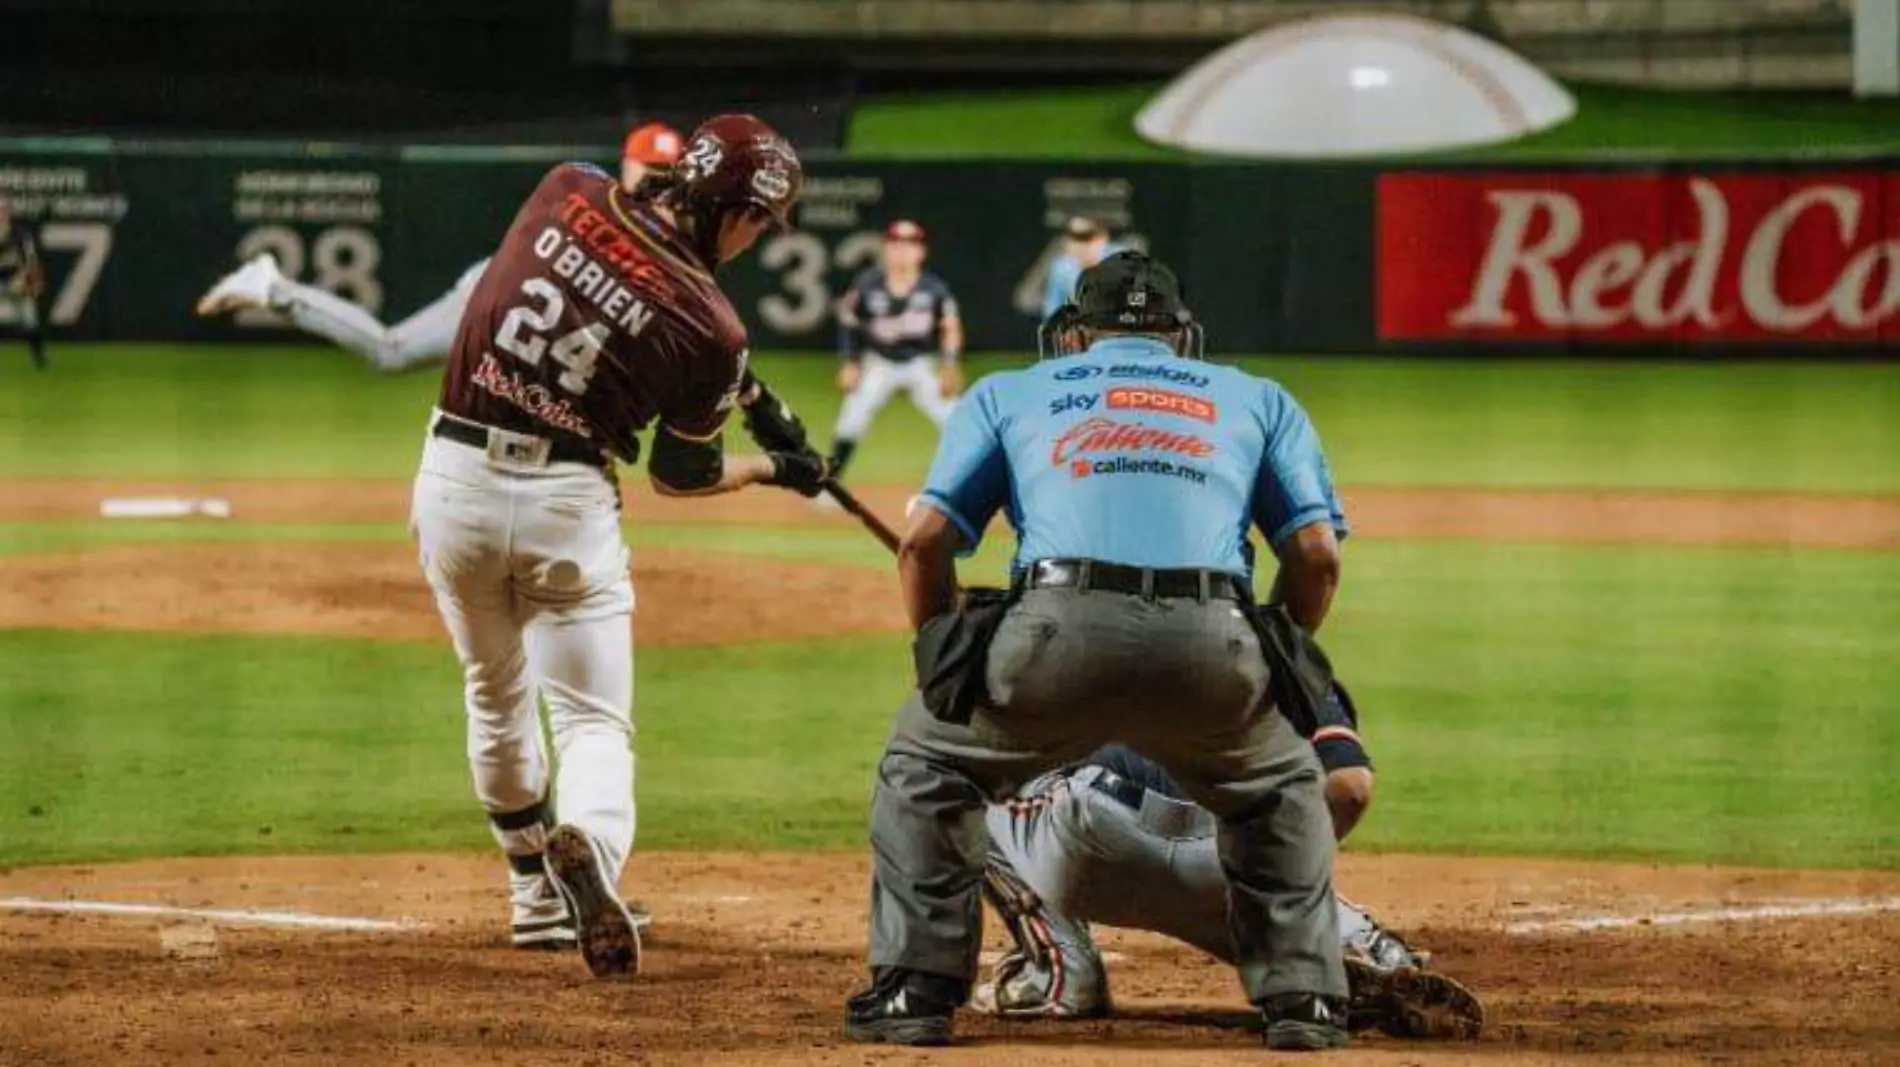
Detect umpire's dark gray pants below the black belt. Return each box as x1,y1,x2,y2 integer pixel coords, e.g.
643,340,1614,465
870,589,1347,1002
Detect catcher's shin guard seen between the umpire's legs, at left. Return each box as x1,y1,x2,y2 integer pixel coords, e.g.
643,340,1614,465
969,858,1110,1020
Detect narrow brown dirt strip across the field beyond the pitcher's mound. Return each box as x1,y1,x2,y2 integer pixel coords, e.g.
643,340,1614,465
0,478,1900,549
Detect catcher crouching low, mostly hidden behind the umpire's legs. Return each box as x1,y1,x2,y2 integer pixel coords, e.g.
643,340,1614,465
971,702,1484,1037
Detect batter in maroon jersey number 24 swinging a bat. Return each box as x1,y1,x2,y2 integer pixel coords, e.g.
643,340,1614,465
412,116,827,976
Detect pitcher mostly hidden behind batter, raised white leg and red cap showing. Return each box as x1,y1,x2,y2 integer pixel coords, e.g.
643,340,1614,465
198,122,682,370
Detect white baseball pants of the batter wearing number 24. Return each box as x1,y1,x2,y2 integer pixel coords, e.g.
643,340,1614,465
412,411,635,879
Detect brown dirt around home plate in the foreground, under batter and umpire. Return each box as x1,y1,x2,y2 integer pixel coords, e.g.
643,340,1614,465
0,854,1900,1067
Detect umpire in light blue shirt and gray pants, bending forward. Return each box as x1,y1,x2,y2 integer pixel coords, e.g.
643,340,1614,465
846,253,1347,1050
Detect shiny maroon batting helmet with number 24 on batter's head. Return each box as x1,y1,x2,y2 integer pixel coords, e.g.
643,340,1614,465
673,114,806,230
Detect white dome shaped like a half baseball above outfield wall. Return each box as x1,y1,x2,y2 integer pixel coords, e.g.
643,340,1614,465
1134,15,1577,158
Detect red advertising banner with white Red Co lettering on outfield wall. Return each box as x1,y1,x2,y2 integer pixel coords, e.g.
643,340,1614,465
1378,171,1900,344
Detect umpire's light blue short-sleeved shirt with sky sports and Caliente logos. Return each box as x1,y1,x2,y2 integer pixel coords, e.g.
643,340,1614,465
922,336,1347,579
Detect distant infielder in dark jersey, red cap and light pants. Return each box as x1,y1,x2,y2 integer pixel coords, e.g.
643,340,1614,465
830,220,963,473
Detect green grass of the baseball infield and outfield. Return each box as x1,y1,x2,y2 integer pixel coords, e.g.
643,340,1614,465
0,346,1900,868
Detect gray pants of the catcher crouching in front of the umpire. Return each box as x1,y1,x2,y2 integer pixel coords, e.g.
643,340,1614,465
986,767,1374,1014
